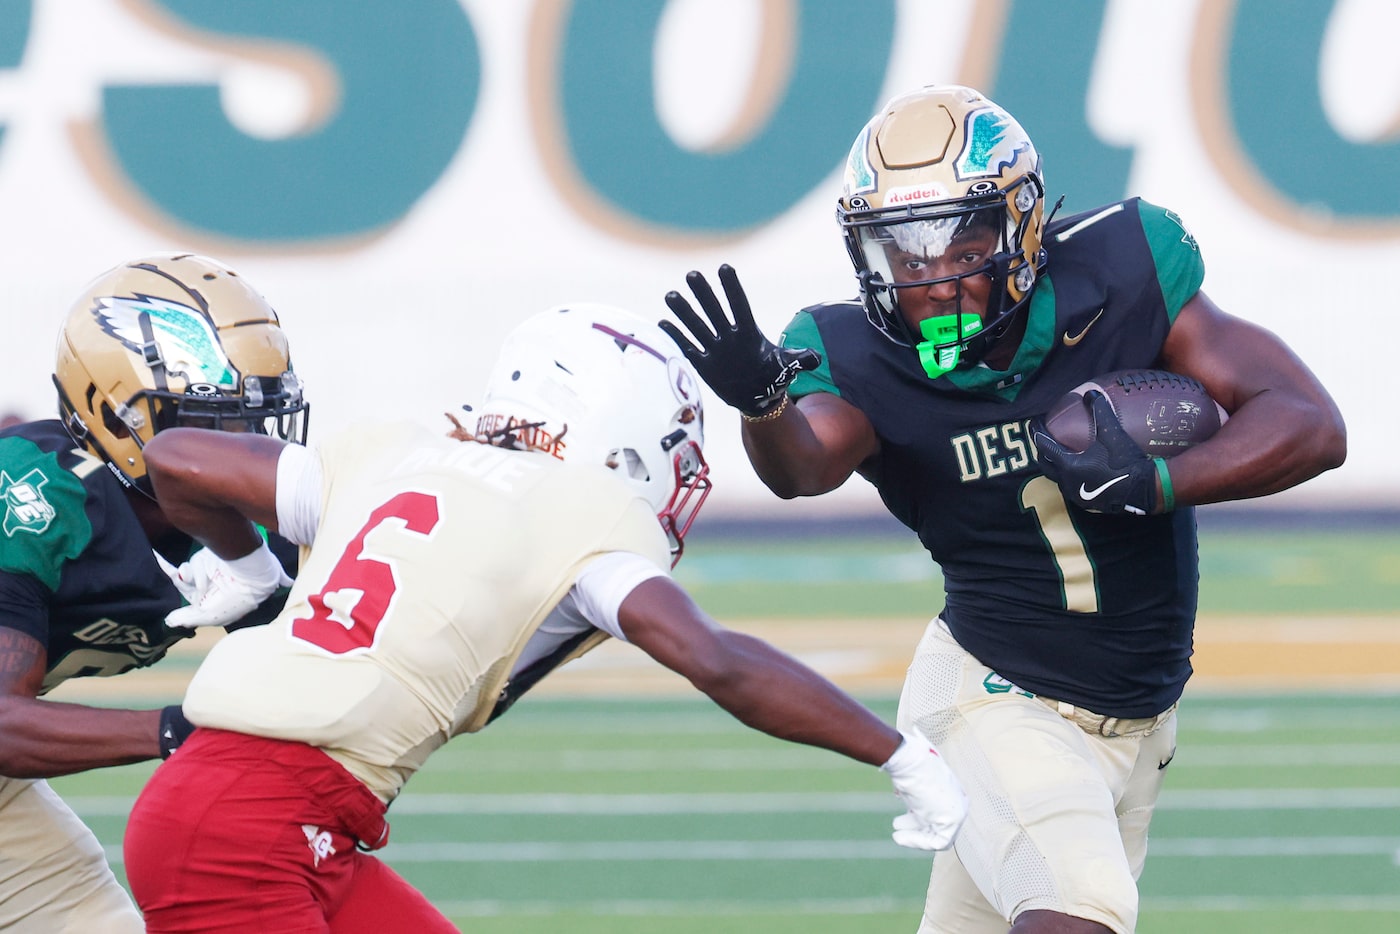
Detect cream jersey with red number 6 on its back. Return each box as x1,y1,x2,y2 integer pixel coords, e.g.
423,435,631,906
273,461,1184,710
183,424,671,801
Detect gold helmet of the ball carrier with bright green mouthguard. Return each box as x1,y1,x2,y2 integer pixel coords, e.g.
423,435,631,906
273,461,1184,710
836,85,1044,378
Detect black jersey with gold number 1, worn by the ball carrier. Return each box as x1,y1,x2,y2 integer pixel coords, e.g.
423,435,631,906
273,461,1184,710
783,199,1204,717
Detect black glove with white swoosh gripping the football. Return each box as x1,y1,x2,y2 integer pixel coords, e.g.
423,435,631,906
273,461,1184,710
1030,389,1161,515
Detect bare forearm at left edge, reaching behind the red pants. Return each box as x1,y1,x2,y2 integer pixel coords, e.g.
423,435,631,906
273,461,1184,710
0,697,161,779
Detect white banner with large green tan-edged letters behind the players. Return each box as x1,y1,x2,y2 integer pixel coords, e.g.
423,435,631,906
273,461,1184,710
0,0,1400,517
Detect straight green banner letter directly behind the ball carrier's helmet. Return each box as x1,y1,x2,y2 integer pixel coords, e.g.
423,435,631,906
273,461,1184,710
979,0,1133,213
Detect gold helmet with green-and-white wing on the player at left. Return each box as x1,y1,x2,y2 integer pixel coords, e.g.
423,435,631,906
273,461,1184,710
53,253,308,496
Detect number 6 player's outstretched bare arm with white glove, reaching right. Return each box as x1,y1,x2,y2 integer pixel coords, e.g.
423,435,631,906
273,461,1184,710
617,577,967,850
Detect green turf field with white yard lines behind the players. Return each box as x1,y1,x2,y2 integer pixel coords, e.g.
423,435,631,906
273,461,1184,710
43,531,1400,934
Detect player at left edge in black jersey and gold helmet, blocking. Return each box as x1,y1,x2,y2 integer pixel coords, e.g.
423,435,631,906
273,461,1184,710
0,253,307,934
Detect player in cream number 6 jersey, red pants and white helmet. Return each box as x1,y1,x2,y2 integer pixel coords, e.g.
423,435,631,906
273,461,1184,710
125,305,966,934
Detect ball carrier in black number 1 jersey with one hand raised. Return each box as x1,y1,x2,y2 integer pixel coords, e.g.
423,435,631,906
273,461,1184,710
662,85,1345,934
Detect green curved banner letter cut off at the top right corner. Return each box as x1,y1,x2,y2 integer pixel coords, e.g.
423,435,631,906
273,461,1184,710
1219,0,1400,221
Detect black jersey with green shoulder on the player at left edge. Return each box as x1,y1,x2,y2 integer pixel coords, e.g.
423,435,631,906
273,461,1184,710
0,420,295,693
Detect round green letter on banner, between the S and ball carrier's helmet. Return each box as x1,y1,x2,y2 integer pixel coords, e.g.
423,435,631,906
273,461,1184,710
547,0,895,234
